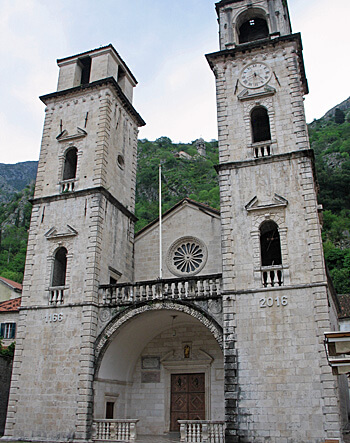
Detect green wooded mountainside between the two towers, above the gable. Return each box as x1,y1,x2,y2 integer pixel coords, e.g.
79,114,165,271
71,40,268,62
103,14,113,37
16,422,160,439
135,137,220,231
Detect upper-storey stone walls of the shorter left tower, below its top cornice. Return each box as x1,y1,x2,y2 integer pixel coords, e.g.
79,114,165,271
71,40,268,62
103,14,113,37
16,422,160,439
35,86,138,211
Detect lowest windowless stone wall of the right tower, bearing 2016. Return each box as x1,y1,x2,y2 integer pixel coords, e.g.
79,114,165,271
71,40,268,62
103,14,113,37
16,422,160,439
230,288,340,443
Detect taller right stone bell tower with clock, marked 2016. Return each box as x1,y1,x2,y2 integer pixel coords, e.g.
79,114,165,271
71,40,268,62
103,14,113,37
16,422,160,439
207,0,342,443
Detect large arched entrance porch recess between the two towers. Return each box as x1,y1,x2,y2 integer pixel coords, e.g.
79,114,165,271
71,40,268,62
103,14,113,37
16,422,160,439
94,302,224,435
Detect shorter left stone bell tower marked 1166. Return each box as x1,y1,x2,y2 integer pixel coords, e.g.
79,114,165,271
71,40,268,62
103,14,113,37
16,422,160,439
5,45,144,441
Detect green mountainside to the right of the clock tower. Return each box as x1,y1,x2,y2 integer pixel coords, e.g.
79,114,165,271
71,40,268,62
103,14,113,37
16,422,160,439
309,98,350,294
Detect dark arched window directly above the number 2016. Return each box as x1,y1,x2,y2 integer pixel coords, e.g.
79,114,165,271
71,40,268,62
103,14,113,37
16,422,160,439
260,220,282,266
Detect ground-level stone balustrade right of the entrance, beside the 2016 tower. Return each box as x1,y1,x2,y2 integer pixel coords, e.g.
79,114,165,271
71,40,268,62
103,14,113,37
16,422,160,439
178,420,225,443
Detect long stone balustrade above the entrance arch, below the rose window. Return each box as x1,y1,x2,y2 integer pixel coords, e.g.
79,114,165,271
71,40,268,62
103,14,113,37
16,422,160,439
99,274,221,305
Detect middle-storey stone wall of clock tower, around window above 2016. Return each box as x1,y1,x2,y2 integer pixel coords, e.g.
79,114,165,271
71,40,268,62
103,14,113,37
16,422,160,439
220,151,326,290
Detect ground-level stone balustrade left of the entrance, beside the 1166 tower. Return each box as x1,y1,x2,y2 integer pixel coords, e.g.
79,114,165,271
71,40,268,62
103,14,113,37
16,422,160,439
92,419,138,442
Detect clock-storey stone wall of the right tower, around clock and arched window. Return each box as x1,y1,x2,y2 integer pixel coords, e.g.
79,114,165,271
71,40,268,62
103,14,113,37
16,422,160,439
212,37,309,163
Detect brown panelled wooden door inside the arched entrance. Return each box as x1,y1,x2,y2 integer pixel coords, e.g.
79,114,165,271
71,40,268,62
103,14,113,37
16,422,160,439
170,374,205,431
